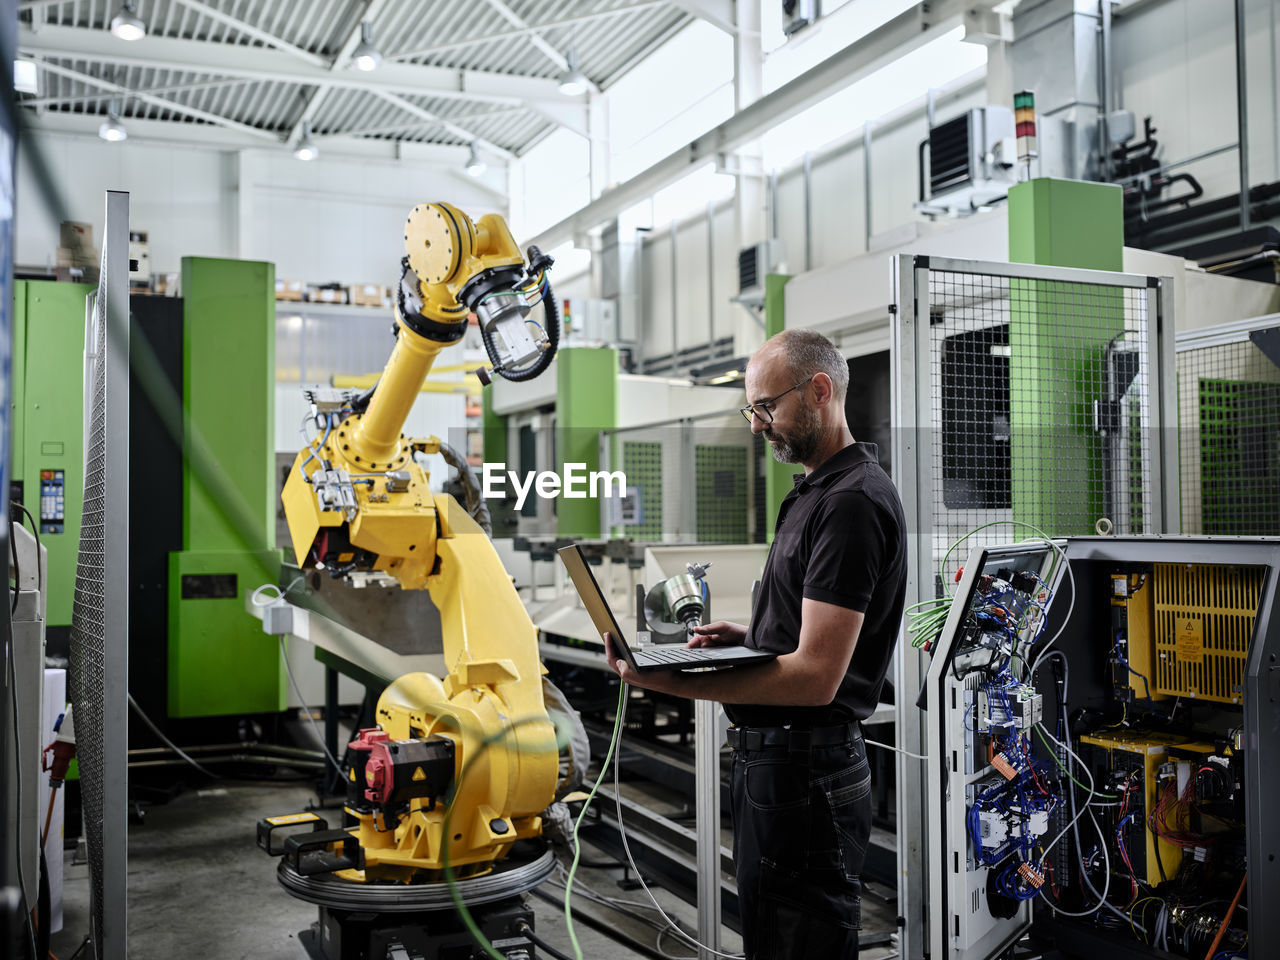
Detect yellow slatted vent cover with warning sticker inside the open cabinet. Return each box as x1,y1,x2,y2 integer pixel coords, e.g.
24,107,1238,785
1152,563,1266,704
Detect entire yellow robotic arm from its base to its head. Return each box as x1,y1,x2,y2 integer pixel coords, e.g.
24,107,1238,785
283,204,558,882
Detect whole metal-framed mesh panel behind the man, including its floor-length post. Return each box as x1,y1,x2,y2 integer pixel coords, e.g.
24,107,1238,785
891,256,1178,956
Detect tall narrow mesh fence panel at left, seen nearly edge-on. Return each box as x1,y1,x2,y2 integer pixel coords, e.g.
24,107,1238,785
70,277,111,956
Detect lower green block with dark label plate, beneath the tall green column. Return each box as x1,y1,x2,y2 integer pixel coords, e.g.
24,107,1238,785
169,550,287,717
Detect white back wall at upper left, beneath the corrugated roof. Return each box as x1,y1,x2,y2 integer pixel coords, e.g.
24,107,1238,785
15,133,506,284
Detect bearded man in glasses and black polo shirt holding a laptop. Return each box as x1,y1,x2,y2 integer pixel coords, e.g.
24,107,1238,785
605,330,906,960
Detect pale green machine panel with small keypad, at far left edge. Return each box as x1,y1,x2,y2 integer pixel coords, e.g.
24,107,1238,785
13,280,95,627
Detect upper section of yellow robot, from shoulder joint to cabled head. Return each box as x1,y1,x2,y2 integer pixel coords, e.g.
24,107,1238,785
284,204,559,590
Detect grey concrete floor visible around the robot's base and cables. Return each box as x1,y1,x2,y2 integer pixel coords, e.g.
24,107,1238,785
51,781,895,960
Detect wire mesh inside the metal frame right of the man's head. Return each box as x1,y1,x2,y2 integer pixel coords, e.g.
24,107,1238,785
902,263,1153,593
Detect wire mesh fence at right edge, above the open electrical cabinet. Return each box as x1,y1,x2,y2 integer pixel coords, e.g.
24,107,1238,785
1178,330,1280,536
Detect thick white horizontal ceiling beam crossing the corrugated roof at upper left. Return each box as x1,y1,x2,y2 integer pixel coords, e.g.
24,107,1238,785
18,23,563,106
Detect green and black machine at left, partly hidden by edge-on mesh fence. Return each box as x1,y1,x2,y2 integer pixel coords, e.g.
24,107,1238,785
12,259,287,721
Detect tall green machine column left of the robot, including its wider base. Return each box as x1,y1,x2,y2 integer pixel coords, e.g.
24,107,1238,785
167,257,287,717
